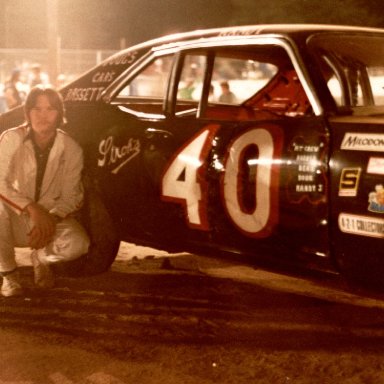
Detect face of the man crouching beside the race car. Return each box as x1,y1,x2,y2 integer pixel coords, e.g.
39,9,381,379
29,95,59,135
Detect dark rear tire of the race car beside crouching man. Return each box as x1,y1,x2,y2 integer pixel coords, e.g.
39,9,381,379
54,178,120,277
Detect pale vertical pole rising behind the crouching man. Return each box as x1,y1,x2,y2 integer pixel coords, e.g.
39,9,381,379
45,0,60,86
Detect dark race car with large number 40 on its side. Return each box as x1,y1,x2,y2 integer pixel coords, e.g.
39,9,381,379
0,25,384,286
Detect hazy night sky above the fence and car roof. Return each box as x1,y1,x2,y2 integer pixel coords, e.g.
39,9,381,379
0,0,384,49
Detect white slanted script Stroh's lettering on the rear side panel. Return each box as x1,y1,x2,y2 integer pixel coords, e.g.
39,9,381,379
97,136,140,174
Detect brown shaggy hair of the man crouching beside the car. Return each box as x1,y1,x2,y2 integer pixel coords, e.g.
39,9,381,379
24,86,64,128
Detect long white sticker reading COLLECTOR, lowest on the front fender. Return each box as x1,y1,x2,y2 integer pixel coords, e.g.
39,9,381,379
339,213,384,239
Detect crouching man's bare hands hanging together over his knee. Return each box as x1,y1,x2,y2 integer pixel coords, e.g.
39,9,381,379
25,203,56,249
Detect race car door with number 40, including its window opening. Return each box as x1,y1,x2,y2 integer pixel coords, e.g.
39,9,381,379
136,44,329,263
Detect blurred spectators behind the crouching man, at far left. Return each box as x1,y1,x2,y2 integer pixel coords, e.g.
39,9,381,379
0,63,50,113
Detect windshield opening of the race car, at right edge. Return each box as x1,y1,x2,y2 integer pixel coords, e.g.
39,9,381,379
308,33,384,113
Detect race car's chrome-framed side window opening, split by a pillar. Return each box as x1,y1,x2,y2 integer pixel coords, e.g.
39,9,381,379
112,45,312,120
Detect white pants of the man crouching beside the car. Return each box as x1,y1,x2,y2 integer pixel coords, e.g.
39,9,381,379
0,201,89,273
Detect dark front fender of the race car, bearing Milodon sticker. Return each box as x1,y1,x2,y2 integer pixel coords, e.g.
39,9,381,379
330,116,384,282
